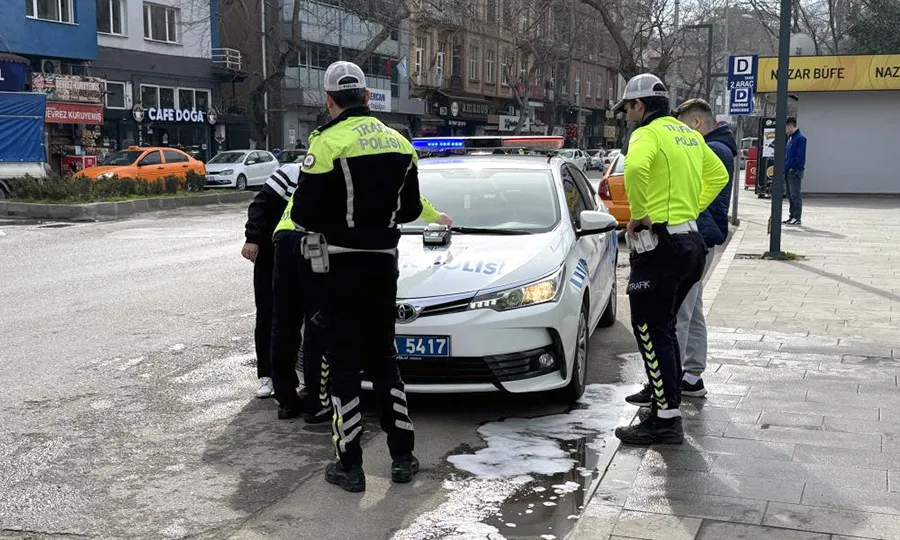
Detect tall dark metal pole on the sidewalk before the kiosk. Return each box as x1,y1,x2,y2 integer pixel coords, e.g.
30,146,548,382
768,0,792,257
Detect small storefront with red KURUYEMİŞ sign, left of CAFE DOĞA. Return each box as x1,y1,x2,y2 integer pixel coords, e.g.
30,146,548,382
31,73,104,174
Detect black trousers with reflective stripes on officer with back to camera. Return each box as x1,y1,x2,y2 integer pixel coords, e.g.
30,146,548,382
321,253,414,467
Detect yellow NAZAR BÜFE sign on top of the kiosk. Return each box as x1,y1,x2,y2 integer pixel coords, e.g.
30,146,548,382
757,54,900,92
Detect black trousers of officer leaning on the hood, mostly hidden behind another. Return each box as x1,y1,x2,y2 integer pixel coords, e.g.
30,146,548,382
271,231,331,414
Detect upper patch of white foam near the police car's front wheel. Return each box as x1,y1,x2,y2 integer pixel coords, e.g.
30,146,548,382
447,384,634,479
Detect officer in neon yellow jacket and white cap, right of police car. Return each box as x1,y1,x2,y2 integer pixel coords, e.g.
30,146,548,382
616,74,728,445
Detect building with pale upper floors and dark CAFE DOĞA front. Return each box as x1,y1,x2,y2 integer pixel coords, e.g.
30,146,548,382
90,0,249,160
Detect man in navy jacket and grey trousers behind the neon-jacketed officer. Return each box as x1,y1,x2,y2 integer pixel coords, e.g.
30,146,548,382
675,99,737,397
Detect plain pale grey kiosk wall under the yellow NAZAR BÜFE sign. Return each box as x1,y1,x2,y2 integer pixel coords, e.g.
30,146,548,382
797,91,900,194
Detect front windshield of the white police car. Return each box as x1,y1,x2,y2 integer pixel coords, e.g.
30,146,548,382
403,168,559,234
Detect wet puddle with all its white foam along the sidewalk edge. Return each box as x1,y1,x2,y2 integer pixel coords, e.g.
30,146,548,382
393,384,635,540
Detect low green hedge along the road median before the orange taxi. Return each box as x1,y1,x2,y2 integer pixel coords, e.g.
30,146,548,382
7,171,206,202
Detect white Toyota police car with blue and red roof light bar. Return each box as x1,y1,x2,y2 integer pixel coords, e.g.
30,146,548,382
380,137,618,400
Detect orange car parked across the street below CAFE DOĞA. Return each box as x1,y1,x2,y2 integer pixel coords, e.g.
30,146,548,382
76,146,206,184
